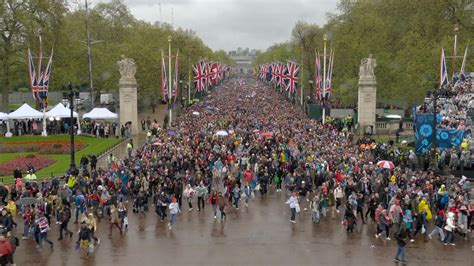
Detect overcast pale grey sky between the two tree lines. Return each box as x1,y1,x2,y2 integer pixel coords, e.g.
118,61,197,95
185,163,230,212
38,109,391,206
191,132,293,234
91,0,339,51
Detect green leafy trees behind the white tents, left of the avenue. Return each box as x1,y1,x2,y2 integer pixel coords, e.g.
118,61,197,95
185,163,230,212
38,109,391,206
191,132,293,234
0,0,232,111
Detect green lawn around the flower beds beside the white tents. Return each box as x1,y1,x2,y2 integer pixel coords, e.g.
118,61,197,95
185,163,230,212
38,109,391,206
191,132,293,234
0,135,120,183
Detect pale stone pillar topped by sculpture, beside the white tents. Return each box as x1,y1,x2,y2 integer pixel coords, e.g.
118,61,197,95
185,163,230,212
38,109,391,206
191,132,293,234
117,56,139,135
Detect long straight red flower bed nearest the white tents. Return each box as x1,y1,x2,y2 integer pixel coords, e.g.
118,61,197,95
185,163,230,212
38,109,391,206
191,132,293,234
0,140,87,154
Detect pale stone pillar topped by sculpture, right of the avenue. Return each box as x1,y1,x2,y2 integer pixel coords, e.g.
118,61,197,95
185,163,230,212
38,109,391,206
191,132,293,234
357,55,377,134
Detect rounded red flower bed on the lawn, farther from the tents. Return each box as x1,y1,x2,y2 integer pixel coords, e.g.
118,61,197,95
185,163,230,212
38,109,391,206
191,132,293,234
0,154,56,176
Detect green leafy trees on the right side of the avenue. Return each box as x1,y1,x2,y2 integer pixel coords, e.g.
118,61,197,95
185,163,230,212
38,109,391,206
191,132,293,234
253,0,474,107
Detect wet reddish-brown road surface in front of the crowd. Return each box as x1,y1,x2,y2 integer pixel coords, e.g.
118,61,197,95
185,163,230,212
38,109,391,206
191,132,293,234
15,190,474,266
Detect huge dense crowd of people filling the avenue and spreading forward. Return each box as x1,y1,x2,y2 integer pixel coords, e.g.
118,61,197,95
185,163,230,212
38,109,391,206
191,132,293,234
0,78,474,262
